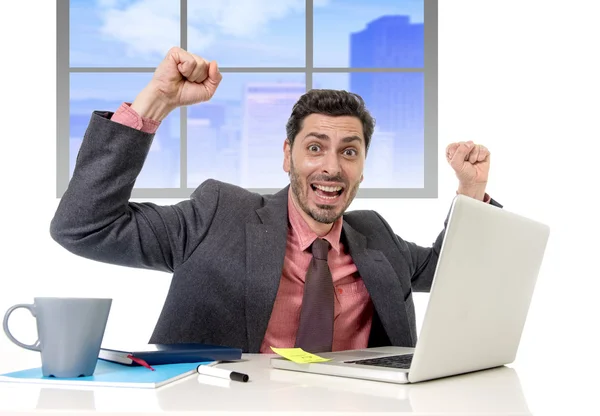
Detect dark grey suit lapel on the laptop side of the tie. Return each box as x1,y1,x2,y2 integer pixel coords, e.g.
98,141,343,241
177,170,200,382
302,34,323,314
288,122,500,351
343,221,414,346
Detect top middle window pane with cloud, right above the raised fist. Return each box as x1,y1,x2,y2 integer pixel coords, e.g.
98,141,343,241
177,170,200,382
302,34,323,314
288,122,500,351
188,0,306,67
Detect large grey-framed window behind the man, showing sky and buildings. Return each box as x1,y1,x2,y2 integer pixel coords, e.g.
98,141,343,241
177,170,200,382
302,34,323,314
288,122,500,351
57,0,437,198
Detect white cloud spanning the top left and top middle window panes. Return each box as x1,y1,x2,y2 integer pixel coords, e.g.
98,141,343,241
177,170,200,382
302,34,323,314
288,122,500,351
97,0,329,58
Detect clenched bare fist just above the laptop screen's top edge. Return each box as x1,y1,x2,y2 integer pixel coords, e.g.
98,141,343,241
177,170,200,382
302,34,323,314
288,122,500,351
446,141,490,200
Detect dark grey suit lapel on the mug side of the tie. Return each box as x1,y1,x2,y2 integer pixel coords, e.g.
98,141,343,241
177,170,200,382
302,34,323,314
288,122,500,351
246,186,289,352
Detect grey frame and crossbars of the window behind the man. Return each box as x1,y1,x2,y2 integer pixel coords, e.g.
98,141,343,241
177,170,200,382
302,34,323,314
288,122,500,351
56,0,438,199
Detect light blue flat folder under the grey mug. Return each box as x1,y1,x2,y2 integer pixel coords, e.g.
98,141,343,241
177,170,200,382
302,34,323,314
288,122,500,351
0,360,211,388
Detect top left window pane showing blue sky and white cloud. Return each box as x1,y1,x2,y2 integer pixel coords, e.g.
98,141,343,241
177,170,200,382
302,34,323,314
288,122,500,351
69,0,180,67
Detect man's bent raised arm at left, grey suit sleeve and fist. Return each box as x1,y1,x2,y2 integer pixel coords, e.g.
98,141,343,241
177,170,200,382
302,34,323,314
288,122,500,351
50,48,222,271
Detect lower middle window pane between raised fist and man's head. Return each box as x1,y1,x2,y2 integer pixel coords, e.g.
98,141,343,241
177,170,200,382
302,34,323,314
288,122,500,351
187,73,306,189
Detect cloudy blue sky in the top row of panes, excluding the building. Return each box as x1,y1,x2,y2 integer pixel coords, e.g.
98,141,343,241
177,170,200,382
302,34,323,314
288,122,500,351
70,0,423,67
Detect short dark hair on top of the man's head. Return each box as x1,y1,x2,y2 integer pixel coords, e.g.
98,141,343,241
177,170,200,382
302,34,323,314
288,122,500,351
285,89,375,150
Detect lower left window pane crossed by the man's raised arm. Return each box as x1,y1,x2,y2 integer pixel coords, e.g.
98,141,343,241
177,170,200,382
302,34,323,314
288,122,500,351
69,73,180,188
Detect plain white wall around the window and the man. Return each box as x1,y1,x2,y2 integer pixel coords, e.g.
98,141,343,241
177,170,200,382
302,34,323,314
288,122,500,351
0,0,600,414
